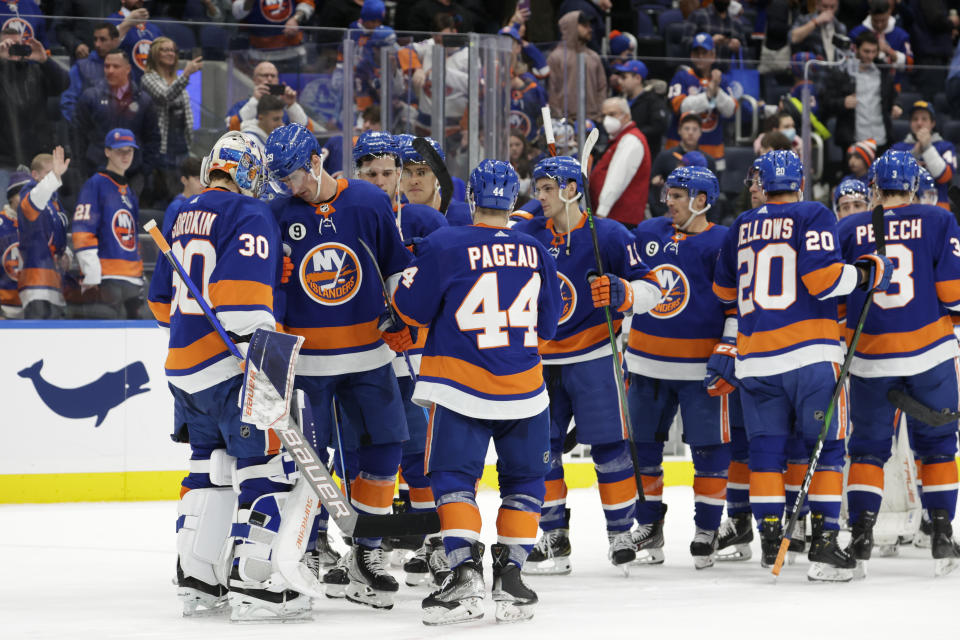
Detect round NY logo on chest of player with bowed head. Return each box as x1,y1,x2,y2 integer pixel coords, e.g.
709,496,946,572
300,242,363,307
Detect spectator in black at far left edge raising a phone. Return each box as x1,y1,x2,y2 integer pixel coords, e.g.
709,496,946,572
0,26,69,184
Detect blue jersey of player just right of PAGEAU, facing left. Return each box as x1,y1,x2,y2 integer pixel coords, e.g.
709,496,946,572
513,214,649,364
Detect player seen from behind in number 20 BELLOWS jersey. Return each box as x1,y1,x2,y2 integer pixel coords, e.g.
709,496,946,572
706,151,892,581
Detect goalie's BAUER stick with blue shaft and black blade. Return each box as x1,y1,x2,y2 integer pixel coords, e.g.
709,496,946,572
143,220,440,538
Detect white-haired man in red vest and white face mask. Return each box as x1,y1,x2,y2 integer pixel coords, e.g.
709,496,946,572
590,98,652,225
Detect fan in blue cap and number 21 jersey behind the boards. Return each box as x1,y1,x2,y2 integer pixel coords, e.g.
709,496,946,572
73,129,144,319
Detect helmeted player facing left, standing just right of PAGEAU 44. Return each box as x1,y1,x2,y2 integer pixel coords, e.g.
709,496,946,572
513,156,660,574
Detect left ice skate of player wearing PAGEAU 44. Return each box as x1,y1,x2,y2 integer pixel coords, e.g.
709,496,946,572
420,543,486,626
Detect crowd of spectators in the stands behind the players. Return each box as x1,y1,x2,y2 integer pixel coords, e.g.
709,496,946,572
0,0,960,318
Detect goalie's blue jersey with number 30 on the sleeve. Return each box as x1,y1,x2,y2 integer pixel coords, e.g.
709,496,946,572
148,189,283,393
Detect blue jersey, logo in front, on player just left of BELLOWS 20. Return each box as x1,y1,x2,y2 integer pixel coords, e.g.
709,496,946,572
627,218,736,380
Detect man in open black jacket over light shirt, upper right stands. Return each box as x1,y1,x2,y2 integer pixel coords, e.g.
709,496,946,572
821,31,902,150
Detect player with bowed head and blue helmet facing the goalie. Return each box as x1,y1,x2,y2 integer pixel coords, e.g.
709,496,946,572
266,124,413,609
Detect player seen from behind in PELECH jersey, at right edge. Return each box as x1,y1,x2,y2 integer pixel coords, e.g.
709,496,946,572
838,150,960,576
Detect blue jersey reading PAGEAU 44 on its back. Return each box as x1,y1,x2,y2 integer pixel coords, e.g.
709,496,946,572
394,225,561,420
